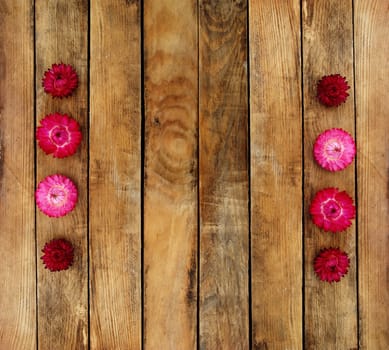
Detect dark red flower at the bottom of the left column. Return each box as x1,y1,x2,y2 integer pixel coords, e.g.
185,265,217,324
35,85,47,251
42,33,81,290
41,239,74,271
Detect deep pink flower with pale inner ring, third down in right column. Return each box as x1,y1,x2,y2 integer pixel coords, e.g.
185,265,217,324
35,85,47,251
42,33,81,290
309,188,355,232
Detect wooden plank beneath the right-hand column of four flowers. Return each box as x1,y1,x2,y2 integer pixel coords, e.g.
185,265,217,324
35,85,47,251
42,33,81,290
302,0,358,350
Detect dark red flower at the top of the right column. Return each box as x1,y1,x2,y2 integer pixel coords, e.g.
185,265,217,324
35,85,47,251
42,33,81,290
317,74,350,107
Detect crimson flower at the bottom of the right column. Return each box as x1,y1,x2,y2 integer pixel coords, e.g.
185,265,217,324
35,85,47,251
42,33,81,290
314,248,350,283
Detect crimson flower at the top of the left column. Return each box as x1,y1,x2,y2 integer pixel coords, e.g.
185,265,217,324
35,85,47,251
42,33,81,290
42,63,78,98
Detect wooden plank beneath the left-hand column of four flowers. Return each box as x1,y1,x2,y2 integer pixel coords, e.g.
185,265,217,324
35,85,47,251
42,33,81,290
35,0,88,350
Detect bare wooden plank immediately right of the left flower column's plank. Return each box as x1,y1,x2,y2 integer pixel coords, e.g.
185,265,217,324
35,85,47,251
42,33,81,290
89,0,142,349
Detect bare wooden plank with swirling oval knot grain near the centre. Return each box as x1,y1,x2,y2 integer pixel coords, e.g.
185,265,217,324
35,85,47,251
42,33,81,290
144,0,198,349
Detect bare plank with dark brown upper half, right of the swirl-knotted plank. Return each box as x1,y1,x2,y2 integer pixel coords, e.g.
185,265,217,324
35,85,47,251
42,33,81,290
199,0,249,349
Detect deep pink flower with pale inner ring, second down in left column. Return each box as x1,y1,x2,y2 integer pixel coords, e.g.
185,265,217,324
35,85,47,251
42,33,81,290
36,113,81,158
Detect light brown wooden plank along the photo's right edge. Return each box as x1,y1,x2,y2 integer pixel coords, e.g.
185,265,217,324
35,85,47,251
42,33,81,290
354,0,389,350
